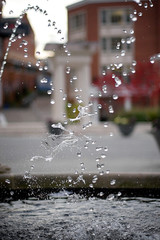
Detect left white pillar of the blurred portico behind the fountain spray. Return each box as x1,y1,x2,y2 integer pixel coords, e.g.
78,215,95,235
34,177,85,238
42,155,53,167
51,61,66,123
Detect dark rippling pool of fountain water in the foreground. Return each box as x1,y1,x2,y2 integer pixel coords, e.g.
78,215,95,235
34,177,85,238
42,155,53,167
0,192,160,240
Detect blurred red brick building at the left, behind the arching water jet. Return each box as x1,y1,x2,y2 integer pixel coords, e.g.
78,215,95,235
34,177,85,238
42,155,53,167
0,15,43,107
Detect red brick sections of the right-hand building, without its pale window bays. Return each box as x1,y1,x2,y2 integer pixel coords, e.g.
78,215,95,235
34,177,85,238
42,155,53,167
68,0,160,77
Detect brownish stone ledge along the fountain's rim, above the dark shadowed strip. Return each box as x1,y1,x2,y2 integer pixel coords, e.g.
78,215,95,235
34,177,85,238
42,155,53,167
0,173,160,190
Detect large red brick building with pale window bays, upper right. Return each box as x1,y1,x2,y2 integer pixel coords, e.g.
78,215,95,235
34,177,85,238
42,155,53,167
68,0,160,79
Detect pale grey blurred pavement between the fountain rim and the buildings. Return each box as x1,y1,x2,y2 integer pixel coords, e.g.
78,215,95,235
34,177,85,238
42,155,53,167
0,97,160,174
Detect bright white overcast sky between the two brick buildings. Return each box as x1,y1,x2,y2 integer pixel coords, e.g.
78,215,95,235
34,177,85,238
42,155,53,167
3,0,80,53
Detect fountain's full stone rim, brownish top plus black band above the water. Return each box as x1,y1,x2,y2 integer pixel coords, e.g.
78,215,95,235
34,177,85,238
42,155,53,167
0,173,160,201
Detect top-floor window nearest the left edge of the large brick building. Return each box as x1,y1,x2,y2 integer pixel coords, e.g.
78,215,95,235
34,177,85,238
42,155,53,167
70,13,86,30
